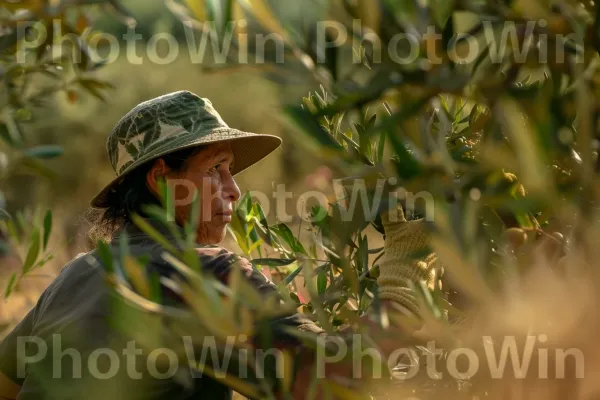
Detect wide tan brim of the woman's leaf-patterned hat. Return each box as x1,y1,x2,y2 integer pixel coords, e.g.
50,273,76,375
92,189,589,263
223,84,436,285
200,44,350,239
90,128,282,208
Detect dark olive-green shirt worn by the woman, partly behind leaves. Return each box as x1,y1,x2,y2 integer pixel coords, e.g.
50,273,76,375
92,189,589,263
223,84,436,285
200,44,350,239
0,220,321,400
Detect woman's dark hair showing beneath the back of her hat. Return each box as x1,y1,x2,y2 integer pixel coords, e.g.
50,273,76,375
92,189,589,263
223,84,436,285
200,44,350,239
86,146,204,245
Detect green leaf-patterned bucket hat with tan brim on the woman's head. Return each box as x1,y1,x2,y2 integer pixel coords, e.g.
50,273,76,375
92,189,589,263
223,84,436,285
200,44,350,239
90,91,281,208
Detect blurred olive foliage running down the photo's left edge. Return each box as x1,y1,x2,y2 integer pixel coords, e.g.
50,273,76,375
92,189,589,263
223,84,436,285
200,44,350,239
0,0,131,318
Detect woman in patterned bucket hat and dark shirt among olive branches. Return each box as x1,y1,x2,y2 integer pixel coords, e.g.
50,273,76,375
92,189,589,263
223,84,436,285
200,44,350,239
0,91,434,400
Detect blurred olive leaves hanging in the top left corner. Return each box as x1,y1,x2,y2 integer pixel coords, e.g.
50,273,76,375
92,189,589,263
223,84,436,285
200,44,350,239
0,1,132,157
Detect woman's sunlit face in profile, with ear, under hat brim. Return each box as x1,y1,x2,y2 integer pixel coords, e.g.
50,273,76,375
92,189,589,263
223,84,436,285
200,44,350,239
151,143,241,244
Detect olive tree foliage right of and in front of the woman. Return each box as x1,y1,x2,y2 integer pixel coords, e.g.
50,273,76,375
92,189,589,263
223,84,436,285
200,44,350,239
7,0,600,398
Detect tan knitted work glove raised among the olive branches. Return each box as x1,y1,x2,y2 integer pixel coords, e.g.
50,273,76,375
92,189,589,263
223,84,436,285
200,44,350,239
377,206,437,316
